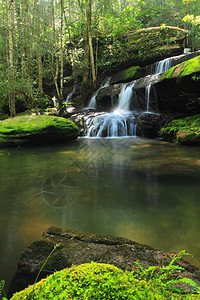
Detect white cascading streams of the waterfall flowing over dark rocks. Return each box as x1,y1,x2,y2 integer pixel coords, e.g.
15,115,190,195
86,54,177,137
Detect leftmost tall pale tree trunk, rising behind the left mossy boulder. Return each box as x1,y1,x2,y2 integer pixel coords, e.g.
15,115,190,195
7,0,16,117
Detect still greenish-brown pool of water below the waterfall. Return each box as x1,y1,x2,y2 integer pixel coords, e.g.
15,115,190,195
0,138,200,290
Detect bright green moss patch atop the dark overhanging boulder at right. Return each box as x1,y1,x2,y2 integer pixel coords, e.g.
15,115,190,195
161,56,200,80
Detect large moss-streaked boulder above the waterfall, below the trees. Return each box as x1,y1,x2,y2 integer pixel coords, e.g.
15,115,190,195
98,26,187,72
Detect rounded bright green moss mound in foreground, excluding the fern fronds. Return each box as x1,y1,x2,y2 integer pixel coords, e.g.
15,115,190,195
11,262,198,300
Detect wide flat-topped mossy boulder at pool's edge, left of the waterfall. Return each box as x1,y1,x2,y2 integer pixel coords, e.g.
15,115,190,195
0,115,78,147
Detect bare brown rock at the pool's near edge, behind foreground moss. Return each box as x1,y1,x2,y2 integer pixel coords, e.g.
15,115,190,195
10,227,200,295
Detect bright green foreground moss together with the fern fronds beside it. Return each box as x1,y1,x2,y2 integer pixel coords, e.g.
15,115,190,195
11,251,200,300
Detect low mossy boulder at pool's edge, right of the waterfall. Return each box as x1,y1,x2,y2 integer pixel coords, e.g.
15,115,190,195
160,114,200,145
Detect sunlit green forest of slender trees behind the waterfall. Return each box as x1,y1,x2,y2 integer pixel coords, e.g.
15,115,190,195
0,0,200,119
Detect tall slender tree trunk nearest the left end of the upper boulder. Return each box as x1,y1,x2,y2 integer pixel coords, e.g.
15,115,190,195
86,0,96,87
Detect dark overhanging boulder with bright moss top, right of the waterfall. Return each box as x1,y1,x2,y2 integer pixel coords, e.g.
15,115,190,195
154,55,200,114
